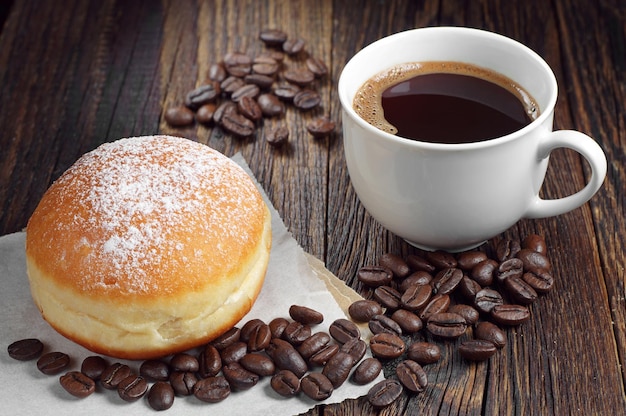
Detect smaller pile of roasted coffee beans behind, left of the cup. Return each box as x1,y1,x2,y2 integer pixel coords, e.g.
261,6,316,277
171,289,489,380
164,29,335,146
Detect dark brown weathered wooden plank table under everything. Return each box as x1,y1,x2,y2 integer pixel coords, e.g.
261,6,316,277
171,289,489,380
0,0,626,415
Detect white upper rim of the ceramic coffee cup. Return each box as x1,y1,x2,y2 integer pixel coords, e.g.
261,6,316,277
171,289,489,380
337,26,558,150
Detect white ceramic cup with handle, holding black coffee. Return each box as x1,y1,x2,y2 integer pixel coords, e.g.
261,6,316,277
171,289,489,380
338,27,607,251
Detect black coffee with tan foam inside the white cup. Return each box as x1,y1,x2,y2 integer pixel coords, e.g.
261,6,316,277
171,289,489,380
354,62,538,143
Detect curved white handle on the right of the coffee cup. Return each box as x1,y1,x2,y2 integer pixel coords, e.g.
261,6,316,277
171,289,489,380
524,130,607,218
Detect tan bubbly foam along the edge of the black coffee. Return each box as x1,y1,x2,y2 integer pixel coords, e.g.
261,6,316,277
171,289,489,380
352,61,539,135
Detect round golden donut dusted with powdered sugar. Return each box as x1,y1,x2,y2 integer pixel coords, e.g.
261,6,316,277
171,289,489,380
26,135,272,359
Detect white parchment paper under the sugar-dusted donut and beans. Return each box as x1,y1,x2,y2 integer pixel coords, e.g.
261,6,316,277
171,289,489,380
0,155,382,416
